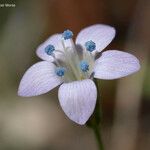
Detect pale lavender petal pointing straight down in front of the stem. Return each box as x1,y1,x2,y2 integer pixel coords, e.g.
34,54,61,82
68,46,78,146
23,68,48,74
58,79,97,125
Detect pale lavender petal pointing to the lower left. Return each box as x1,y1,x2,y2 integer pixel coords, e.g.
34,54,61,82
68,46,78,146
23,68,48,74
18,61,62,97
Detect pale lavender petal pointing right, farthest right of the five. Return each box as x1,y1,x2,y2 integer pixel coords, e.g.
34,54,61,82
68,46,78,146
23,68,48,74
94,50,140,79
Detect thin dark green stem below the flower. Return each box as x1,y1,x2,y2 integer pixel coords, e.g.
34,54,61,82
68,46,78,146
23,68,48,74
86,79,104,150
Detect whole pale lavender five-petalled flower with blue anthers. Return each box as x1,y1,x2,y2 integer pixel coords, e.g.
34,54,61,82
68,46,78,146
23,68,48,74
18,24,140,125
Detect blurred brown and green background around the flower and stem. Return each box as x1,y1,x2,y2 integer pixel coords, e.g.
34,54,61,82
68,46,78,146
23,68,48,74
0,0,150,150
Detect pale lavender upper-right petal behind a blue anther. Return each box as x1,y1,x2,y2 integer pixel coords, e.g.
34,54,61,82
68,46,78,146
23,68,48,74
76,24,115,52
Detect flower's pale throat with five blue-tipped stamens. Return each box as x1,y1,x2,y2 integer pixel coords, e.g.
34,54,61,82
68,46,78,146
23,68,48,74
45,30,96,82
